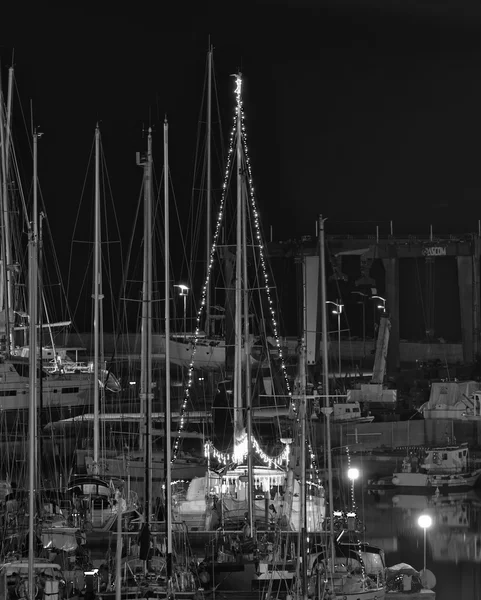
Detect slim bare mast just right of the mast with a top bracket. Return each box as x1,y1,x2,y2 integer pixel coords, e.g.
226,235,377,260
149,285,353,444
164,117,172,589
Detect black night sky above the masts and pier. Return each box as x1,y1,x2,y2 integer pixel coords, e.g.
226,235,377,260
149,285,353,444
4,0,481,335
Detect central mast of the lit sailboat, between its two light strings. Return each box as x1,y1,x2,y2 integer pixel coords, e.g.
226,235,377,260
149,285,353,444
234,73,243,450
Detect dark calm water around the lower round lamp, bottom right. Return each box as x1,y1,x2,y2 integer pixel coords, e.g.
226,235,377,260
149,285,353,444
358,490,481,600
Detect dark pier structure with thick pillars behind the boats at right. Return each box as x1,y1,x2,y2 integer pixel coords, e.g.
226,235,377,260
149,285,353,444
269,231,481,371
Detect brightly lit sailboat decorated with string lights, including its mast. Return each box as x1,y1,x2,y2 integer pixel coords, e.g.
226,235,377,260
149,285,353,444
174,75,324,591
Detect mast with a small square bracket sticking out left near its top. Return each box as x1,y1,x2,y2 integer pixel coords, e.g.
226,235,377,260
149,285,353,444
140,127,153,524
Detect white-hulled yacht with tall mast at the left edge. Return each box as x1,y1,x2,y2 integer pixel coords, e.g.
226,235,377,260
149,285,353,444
0,68,106,426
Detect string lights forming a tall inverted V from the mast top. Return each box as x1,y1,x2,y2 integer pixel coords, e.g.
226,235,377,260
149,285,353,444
172,75,296,462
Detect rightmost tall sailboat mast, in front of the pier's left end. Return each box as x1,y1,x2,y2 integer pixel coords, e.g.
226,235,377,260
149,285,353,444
319,215,336,569
